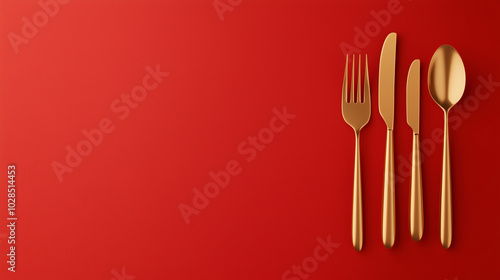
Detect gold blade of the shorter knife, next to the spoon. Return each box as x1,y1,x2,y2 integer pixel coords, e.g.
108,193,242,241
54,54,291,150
406,59,420,134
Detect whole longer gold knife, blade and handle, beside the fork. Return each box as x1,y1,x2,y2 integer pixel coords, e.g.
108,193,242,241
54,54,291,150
378,33,396,248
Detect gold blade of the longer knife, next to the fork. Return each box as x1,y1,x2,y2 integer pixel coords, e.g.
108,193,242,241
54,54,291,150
378,32,397,129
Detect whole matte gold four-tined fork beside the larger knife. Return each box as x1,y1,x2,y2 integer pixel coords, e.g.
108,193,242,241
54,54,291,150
342,55,371,251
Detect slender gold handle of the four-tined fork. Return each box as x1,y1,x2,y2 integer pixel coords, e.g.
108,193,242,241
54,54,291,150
352,131,363,252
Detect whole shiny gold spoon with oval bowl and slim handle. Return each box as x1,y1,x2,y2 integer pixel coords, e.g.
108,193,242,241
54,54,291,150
427,45,465,249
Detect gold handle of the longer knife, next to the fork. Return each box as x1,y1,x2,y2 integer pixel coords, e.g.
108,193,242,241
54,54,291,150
382,129,396,248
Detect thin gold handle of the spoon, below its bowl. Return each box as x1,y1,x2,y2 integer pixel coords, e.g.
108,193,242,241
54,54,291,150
441,112,452,249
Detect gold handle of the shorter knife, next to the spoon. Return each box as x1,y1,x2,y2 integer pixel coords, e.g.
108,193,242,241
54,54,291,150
410,133,424,241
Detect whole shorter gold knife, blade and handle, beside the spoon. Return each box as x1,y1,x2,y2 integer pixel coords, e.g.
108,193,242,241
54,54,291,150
406,59,424,241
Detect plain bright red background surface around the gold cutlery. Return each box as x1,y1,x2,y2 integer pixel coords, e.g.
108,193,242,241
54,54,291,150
0,0,500,280
